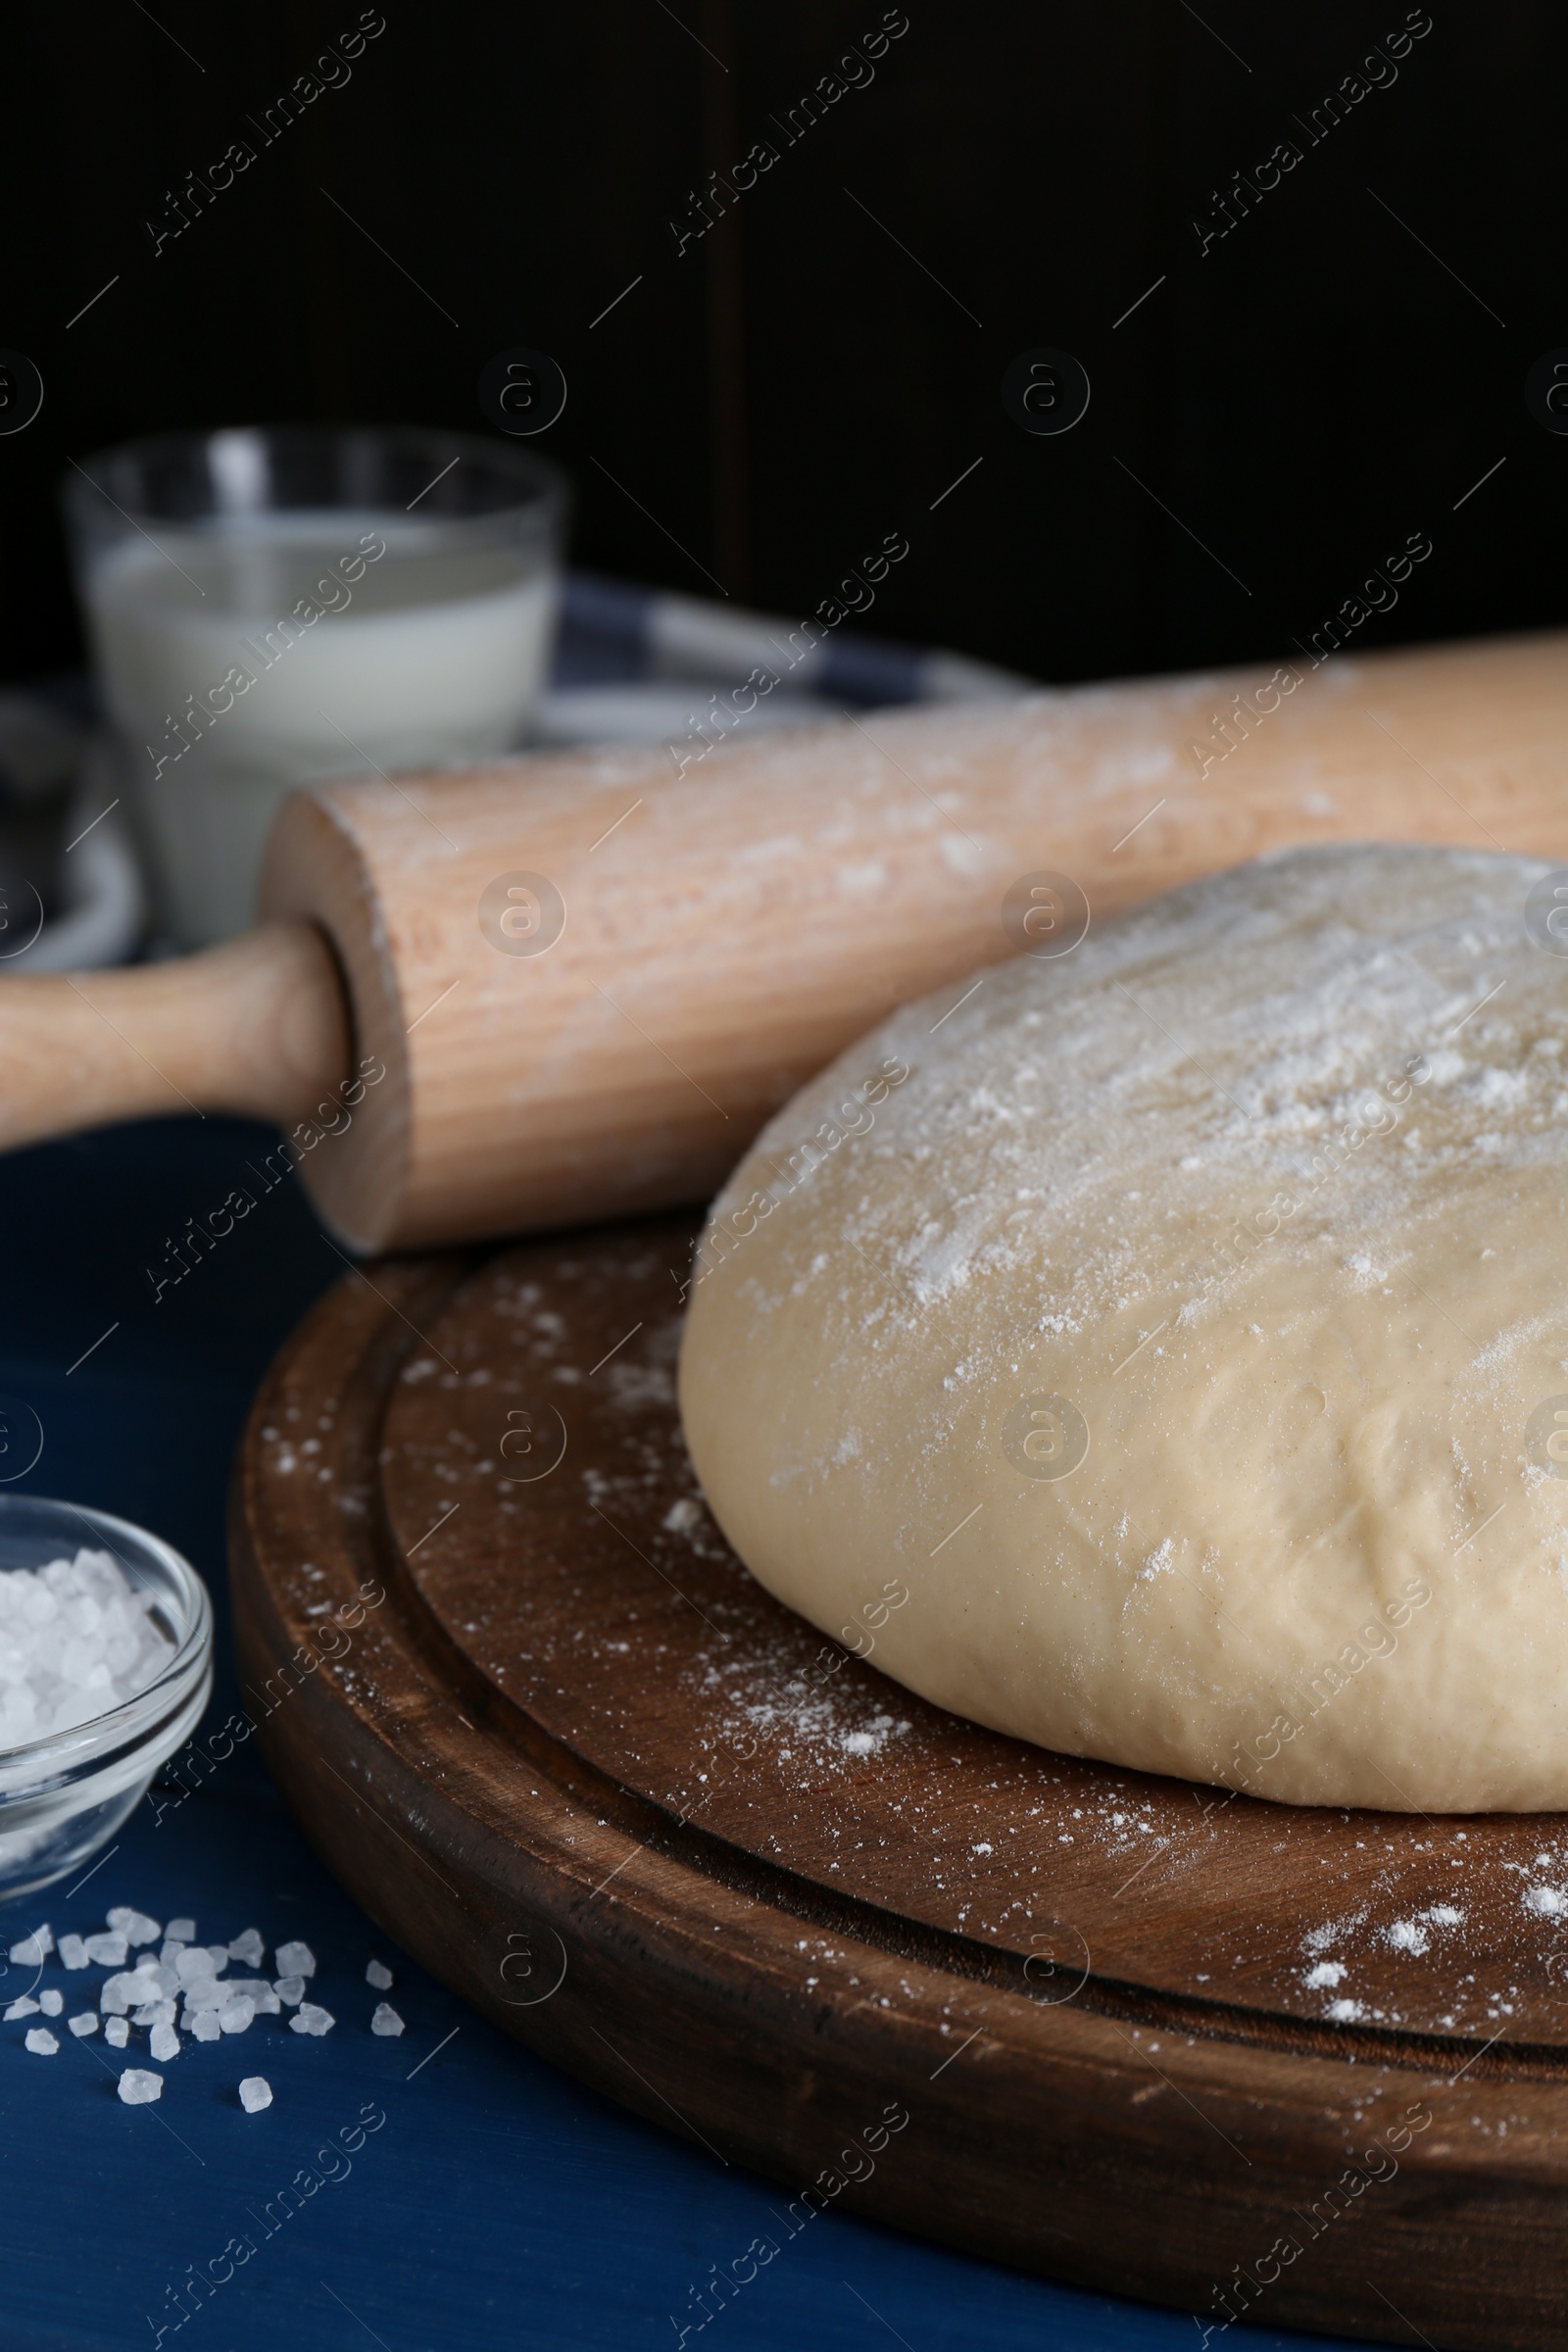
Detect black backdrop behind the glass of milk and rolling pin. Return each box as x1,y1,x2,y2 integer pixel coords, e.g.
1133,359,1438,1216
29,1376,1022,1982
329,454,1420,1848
0,0,1568,680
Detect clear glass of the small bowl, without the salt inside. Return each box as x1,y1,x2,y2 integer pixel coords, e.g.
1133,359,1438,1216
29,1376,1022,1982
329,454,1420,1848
0,1494,212,1903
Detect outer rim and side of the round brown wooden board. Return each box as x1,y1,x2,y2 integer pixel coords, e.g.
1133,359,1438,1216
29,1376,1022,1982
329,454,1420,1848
230,1270,1568,2352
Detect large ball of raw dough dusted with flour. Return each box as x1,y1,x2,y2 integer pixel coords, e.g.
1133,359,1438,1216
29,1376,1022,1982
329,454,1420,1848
682,847,1568,1811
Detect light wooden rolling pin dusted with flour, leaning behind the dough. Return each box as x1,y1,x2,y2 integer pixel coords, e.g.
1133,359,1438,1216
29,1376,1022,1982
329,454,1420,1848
0,635,1568,1249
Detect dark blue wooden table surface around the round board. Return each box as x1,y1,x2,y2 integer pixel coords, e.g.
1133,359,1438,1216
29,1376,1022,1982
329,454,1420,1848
0,1119,1372,2352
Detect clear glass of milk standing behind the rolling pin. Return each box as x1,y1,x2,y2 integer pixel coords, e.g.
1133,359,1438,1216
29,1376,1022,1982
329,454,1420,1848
66,425,566,948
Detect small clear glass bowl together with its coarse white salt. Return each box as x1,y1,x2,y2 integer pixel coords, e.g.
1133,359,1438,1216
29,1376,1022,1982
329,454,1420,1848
0,1494,212,1900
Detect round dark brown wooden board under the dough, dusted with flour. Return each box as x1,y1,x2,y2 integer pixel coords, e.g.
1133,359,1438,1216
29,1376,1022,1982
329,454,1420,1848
230,1218,1568,2347
